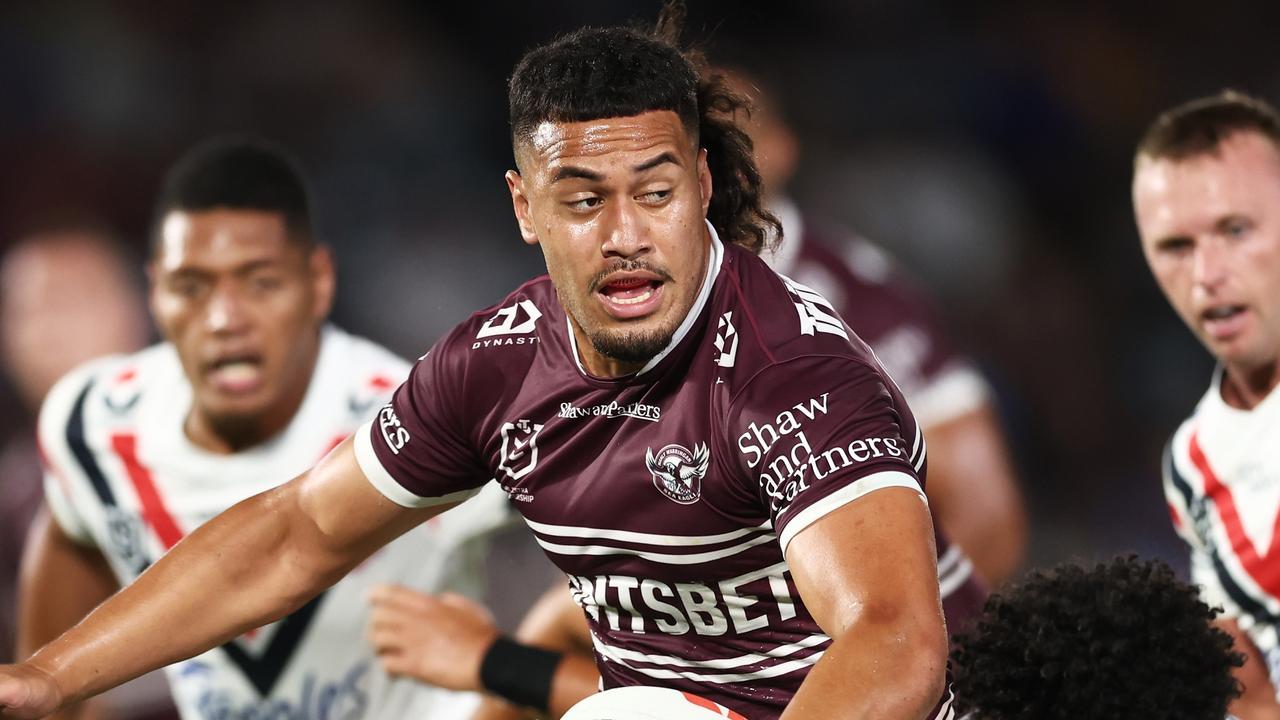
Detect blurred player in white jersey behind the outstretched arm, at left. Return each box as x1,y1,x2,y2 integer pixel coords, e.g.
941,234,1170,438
20,138,506,720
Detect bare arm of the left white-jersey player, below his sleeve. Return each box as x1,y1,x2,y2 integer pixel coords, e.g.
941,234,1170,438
18,506,120,720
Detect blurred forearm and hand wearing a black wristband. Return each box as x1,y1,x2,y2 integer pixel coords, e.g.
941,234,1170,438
369,584,600,720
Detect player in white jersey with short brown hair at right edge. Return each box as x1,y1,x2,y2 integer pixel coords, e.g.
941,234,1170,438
1133,92,1280,720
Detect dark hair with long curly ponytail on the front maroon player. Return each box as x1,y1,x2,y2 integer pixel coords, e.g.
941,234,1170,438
507,1,782,252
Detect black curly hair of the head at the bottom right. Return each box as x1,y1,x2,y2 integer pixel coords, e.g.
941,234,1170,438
951,556,1244,720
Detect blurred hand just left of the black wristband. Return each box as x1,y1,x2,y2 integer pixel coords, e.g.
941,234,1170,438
369,585,498,691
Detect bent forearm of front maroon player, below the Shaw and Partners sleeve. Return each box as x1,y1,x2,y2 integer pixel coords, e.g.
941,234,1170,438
782,623,947,720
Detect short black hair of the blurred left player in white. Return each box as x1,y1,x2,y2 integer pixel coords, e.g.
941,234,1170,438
151,136,314,247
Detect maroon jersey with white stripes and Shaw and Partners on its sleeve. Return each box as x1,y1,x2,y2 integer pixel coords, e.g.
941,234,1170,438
356,226,947,720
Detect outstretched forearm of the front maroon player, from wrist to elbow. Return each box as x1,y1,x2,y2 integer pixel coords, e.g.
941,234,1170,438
31,486,356,703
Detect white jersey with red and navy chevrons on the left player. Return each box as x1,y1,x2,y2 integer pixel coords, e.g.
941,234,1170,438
40,327,508,720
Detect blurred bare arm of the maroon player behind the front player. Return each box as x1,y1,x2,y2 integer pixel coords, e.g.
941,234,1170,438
924,402,1027,585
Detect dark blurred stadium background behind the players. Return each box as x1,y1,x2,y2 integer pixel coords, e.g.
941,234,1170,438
0,0,1280,591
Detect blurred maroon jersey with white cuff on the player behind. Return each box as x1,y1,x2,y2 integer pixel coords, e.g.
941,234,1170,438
765,201,988,625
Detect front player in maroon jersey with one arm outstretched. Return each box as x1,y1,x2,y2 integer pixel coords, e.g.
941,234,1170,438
0,9,952,720
